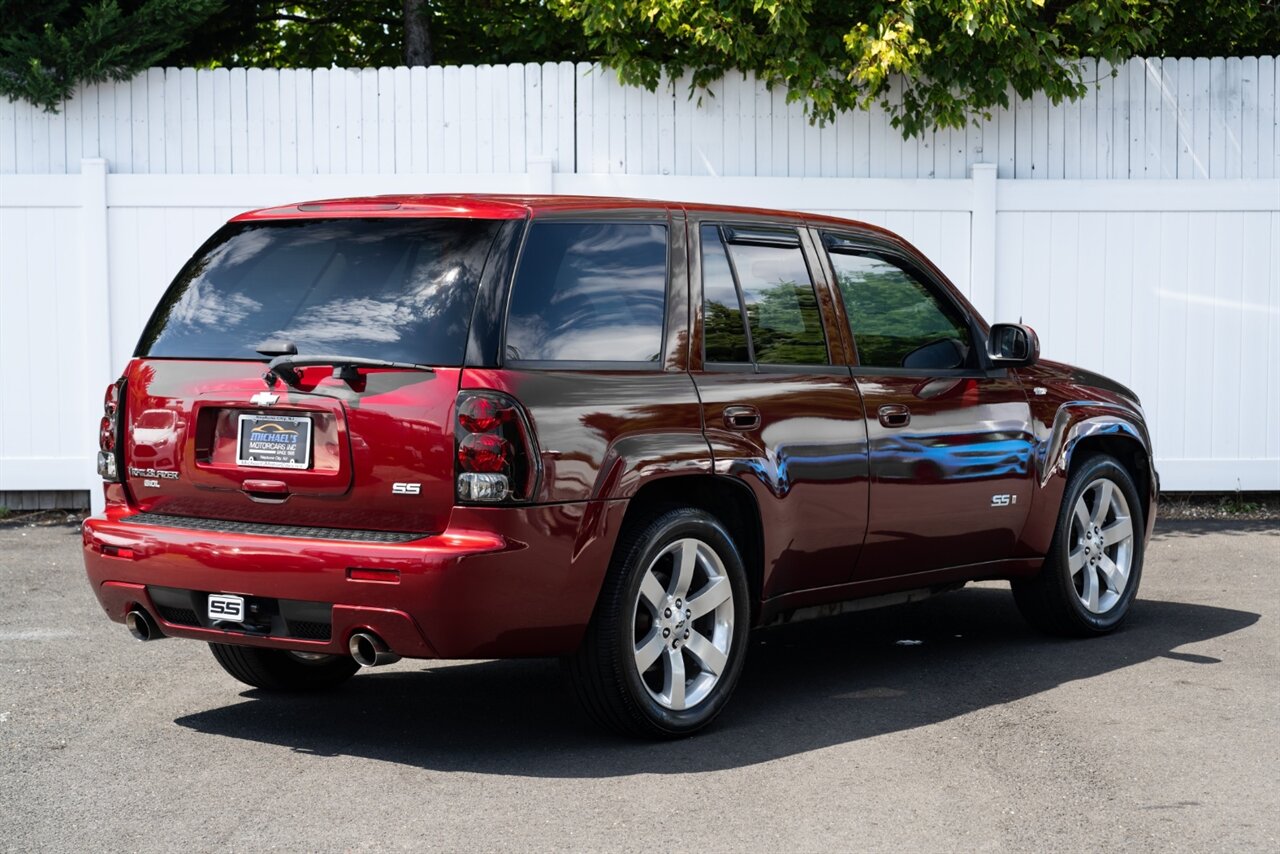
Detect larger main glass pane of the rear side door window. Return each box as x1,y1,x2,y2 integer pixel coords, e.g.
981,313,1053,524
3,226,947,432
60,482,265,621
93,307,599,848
728,243,827,365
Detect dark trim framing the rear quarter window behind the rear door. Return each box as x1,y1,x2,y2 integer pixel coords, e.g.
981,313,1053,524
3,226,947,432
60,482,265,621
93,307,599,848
498,210,675,374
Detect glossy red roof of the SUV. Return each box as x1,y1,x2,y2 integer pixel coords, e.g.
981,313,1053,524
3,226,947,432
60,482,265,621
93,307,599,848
232,193,882,230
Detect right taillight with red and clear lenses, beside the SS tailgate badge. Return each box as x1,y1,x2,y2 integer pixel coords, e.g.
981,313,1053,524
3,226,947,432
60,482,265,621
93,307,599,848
454,391,538,504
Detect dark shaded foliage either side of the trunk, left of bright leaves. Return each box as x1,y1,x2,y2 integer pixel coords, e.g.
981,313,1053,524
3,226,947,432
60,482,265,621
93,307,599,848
0,0,588,109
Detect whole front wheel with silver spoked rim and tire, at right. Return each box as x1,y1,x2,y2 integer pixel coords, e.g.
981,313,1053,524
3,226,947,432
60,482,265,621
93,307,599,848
1012,456,1144,636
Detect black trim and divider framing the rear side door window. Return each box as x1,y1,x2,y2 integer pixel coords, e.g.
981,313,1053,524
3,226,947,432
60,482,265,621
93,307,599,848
691,216,845,374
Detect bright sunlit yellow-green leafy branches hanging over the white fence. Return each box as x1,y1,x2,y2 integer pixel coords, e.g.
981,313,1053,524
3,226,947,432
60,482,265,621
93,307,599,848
550,0,1167,134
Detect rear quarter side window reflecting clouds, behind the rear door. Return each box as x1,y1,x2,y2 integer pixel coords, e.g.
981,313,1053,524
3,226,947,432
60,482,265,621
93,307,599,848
507,223,667,362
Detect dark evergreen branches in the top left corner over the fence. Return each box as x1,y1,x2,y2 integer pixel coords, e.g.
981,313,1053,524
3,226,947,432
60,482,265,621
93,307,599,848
0,0,223,110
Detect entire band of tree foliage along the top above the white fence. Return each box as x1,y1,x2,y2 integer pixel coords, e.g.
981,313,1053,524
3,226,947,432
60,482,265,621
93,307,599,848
0,0,1280,133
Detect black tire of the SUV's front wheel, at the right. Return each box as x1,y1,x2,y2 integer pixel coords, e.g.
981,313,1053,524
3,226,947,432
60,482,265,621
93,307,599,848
1012,455,1146,638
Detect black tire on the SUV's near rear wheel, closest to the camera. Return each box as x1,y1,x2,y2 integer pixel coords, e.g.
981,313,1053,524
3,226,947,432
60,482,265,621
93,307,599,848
563,507,751,739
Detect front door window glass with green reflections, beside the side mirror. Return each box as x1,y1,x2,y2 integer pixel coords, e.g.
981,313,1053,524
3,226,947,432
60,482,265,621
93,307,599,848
831,252,969,369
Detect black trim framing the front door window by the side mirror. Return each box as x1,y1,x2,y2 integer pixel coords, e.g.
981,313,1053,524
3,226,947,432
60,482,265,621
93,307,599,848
813,225,1007,376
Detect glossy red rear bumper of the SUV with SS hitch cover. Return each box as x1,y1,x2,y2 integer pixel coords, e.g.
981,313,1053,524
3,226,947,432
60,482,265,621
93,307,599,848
83,502,626,658
